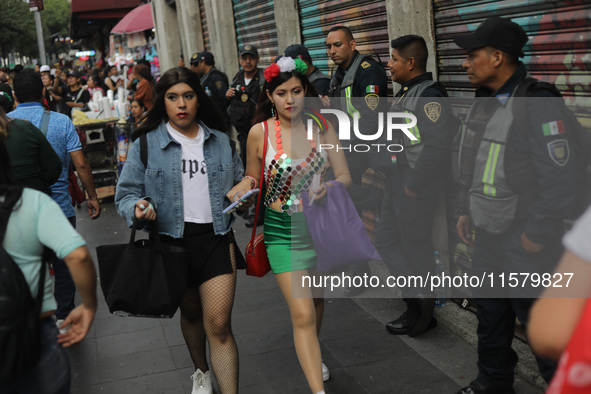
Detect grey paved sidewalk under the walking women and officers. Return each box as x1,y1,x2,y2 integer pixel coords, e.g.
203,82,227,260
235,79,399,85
70,202,542,394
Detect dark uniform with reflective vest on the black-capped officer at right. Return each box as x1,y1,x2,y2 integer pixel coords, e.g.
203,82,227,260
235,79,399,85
460,64,579,392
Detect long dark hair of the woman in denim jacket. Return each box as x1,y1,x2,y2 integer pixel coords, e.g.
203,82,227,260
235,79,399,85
131,67,225,141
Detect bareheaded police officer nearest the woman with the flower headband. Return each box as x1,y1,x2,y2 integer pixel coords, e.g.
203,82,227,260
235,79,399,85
326,26,388,297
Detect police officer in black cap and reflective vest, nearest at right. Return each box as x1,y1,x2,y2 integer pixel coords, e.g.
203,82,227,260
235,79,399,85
454,17,579,394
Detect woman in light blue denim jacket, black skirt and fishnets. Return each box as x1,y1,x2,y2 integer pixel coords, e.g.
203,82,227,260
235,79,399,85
115,67,246,394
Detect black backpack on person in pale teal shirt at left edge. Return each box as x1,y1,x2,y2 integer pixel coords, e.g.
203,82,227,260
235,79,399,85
0,208,49,381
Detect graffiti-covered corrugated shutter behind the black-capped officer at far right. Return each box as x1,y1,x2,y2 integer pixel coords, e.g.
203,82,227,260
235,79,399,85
434,0,591,284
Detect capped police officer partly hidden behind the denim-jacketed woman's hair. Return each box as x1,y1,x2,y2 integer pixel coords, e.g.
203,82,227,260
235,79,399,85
197,51,229,127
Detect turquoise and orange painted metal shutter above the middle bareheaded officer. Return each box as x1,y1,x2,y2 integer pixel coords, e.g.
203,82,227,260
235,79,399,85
298,0,390,73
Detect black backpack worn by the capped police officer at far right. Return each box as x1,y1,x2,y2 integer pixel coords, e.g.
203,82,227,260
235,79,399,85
513,77,591,213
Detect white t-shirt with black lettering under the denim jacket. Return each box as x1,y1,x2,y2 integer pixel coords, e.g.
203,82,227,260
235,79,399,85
166,122,213,223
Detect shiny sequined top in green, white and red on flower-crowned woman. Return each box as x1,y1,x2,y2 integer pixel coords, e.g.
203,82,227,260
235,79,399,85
265,127,327,215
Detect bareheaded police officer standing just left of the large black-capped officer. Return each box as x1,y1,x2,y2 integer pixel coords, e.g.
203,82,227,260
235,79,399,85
372,35,451,337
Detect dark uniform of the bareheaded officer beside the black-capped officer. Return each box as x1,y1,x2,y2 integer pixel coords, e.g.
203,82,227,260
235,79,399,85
375,73,451,308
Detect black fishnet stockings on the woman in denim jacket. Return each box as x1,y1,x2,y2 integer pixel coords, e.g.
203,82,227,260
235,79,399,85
181,243,238,394
